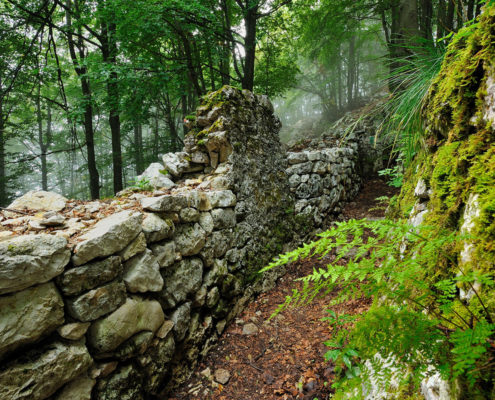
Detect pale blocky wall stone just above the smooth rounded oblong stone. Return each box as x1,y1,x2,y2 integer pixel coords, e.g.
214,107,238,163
124,250,163,293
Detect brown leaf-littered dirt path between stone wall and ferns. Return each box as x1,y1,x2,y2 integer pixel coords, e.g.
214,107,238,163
168,179,396,400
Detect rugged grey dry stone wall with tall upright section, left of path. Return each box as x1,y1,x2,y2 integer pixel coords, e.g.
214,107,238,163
0,87,359,400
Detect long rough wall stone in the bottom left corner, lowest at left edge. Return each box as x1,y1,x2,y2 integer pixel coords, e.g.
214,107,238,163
0,342,92,400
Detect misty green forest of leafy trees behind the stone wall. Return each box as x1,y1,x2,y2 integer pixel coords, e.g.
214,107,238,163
0,0,484,206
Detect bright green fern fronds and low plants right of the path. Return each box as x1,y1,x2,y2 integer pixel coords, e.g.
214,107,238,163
263,220,495,399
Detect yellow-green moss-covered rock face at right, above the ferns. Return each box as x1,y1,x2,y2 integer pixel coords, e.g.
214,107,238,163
395,6,495,396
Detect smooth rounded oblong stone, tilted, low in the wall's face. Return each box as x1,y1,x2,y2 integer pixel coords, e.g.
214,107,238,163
88,297,165,353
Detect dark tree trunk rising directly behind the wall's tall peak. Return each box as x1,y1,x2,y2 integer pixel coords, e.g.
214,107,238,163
242,0,259,91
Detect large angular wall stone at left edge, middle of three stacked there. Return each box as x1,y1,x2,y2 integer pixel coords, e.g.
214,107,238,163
0,282,64,358
